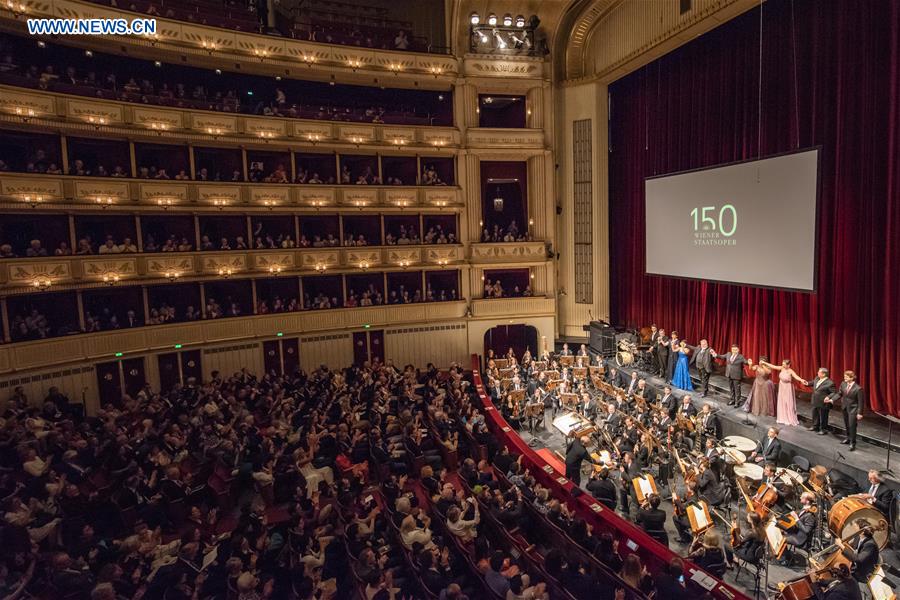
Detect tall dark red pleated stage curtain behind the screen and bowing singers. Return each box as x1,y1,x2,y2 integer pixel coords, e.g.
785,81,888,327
610,0,900,415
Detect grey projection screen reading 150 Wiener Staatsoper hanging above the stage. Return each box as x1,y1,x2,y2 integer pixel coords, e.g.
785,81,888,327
644,149,819,291
